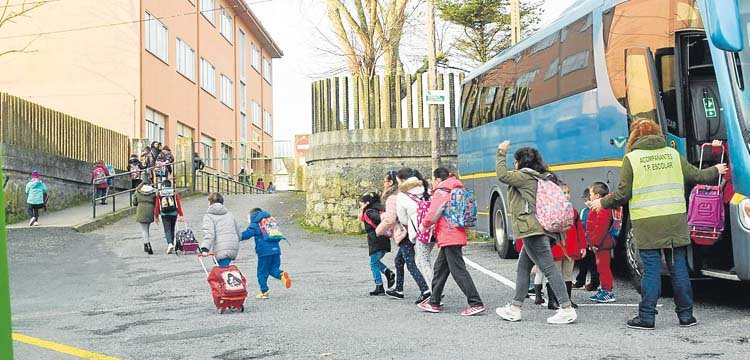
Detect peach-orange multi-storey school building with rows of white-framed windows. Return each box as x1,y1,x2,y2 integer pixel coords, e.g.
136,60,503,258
0,0,283,174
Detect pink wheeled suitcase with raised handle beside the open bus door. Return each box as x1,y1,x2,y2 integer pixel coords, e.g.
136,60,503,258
688,144,725,245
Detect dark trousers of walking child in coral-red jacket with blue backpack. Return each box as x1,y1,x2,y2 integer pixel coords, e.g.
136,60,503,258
430,245,483,306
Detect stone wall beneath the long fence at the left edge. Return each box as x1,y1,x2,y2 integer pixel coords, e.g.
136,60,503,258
0,144,130,223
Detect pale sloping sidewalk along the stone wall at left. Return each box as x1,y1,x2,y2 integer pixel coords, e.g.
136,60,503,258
6,193,135,229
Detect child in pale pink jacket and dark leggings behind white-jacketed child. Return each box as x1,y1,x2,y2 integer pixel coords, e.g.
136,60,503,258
375,171,430,304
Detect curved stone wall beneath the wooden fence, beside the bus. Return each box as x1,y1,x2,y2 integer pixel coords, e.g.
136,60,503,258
305,128,457,233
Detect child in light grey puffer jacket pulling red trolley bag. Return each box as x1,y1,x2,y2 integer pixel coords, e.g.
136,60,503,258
200,192,241,267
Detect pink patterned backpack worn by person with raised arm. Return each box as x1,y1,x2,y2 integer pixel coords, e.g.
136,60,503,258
534,172,575,233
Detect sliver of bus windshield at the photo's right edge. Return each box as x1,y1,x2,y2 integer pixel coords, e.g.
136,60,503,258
732,1,750,147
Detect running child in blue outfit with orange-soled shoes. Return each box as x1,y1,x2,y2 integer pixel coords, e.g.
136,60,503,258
240,208,292,299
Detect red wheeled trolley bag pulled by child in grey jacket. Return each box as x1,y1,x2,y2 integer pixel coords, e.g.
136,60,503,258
198,253,247,314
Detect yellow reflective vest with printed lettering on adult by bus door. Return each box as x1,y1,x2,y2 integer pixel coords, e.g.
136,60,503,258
625,147,687,220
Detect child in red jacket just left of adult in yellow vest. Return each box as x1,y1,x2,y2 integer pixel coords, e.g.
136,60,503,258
586,182,616,303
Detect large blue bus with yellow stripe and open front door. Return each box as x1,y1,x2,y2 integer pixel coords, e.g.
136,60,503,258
458,0,750,281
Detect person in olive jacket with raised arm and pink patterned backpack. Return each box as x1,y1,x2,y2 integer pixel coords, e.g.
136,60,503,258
496,140,578,324
